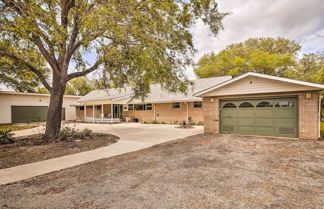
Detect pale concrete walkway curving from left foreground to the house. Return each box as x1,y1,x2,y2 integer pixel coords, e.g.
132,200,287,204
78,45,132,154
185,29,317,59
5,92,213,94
0,123,203,184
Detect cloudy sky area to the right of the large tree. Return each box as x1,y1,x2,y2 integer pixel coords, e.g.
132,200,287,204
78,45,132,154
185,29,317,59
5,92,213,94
187,0,324,78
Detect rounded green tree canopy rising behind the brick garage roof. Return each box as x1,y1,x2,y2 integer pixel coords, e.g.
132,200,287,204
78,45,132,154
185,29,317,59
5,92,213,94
195,38,301,78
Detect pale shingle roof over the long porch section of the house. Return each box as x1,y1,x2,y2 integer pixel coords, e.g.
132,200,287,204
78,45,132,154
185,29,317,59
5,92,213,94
78,76,232,103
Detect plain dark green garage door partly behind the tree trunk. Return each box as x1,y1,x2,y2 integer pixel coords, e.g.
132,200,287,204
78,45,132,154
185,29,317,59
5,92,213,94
11,106,65,123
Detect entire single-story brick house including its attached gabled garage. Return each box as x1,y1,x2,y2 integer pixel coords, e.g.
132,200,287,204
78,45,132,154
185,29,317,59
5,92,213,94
76,73,324,139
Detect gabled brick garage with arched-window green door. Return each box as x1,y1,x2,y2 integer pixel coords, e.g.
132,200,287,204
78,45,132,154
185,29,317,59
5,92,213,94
194,73,324,139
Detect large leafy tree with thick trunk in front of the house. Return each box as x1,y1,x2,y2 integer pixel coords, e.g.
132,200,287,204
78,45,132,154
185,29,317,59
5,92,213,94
0,0,226,139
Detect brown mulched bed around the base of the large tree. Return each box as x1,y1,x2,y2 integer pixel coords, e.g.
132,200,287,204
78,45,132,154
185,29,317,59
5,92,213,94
0,133,118,169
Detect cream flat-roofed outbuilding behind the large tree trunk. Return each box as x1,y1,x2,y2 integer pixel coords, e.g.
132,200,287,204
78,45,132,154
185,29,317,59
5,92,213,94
0,91,80,124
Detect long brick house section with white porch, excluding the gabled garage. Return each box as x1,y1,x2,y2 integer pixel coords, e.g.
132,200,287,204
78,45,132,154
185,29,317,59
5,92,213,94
76,76,231,123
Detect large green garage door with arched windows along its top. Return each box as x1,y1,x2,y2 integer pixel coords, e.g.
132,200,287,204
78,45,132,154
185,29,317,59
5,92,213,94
220,97,298,137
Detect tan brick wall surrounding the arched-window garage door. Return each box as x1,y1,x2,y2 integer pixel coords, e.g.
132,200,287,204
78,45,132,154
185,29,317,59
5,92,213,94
203,91,319,139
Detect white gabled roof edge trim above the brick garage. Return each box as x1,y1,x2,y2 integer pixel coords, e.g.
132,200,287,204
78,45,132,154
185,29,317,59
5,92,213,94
194,72,324,97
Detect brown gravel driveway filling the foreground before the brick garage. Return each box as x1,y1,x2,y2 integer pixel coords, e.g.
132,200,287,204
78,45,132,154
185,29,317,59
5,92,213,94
0,135,324,209
